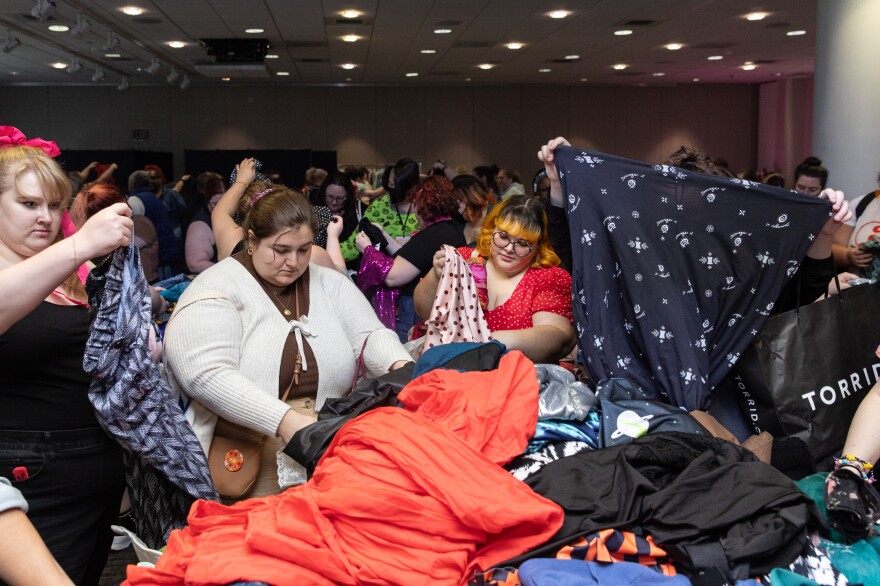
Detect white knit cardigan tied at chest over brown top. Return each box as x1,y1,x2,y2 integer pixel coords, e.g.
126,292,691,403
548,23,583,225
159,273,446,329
165,258,410,454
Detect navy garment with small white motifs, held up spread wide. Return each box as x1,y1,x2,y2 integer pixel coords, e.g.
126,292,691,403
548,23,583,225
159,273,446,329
556,147,831,410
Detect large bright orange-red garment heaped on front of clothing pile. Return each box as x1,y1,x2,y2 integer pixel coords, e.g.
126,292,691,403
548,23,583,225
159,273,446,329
126,352,563,585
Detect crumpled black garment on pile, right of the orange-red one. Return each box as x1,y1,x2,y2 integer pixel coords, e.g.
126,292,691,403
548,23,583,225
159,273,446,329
499,432,827,579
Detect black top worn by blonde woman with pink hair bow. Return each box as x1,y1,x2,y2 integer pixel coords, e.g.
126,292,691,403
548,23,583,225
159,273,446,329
0,301,98,431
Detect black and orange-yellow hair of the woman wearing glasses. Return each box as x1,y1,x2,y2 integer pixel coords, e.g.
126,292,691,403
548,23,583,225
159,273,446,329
477,195,561,268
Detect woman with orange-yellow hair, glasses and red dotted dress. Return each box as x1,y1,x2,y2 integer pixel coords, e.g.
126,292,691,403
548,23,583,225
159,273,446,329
414,196,575,362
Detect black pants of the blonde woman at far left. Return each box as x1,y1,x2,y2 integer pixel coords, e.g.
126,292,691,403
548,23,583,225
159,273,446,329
0,427,123,585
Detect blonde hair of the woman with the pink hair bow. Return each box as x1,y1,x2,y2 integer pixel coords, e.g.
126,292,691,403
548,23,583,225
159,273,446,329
0,146,88,300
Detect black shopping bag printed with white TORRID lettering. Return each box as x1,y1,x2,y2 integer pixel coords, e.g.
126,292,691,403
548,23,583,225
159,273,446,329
728,278,880,469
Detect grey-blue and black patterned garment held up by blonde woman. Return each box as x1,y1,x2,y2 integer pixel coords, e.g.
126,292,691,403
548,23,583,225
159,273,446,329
83,242,218,548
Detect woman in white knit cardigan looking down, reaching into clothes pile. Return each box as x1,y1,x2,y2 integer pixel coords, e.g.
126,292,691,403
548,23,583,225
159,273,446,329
165,183,409,496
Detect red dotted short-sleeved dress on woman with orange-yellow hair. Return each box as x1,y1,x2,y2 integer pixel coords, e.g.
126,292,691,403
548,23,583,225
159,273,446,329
458,246,572,332
